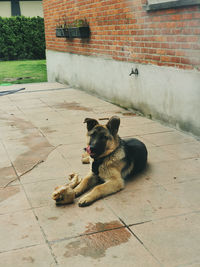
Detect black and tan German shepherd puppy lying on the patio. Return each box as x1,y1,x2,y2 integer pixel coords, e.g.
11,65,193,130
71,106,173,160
74,116,147,207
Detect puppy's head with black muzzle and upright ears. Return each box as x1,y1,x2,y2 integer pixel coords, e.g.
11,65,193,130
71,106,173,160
84,116,120,159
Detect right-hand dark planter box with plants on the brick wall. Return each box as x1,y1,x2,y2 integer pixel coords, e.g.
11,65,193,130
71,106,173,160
68,19,90,38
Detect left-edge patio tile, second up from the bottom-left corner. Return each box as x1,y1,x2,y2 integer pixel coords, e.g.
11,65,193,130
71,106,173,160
0,210,45,252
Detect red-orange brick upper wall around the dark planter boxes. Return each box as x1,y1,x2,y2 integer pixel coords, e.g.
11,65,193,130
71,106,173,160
43,0,200,71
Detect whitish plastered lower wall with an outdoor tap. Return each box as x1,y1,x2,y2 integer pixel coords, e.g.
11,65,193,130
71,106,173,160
46,50,200,136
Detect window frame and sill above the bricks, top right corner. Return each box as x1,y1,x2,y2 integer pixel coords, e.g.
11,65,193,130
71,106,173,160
146,0,200,11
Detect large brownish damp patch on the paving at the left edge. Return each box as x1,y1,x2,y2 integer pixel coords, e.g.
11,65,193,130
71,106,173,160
0,115,54,186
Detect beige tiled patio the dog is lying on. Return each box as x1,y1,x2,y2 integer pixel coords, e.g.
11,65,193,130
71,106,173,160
0,83,200,267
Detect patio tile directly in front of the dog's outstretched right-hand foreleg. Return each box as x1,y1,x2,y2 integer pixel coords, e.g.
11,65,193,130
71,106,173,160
104,183,190,225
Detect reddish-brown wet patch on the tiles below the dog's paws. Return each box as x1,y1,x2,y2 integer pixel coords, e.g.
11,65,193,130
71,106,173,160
64,221,131,259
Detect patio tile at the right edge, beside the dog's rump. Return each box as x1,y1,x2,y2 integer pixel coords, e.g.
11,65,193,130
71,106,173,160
148,158,200,185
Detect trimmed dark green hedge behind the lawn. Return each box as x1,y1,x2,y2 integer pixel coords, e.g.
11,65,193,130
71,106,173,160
0,16,45,60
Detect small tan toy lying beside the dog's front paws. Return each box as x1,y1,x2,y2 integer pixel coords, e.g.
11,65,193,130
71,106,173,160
52,173,81,205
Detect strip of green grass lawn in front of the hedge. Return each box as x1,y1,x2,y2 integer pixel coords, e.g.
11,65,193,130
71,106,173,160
0,60,47,86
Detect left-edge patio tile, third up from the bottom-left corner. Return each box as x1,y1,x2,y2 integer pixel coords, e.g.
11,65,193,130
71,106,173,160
0,185,30,214
